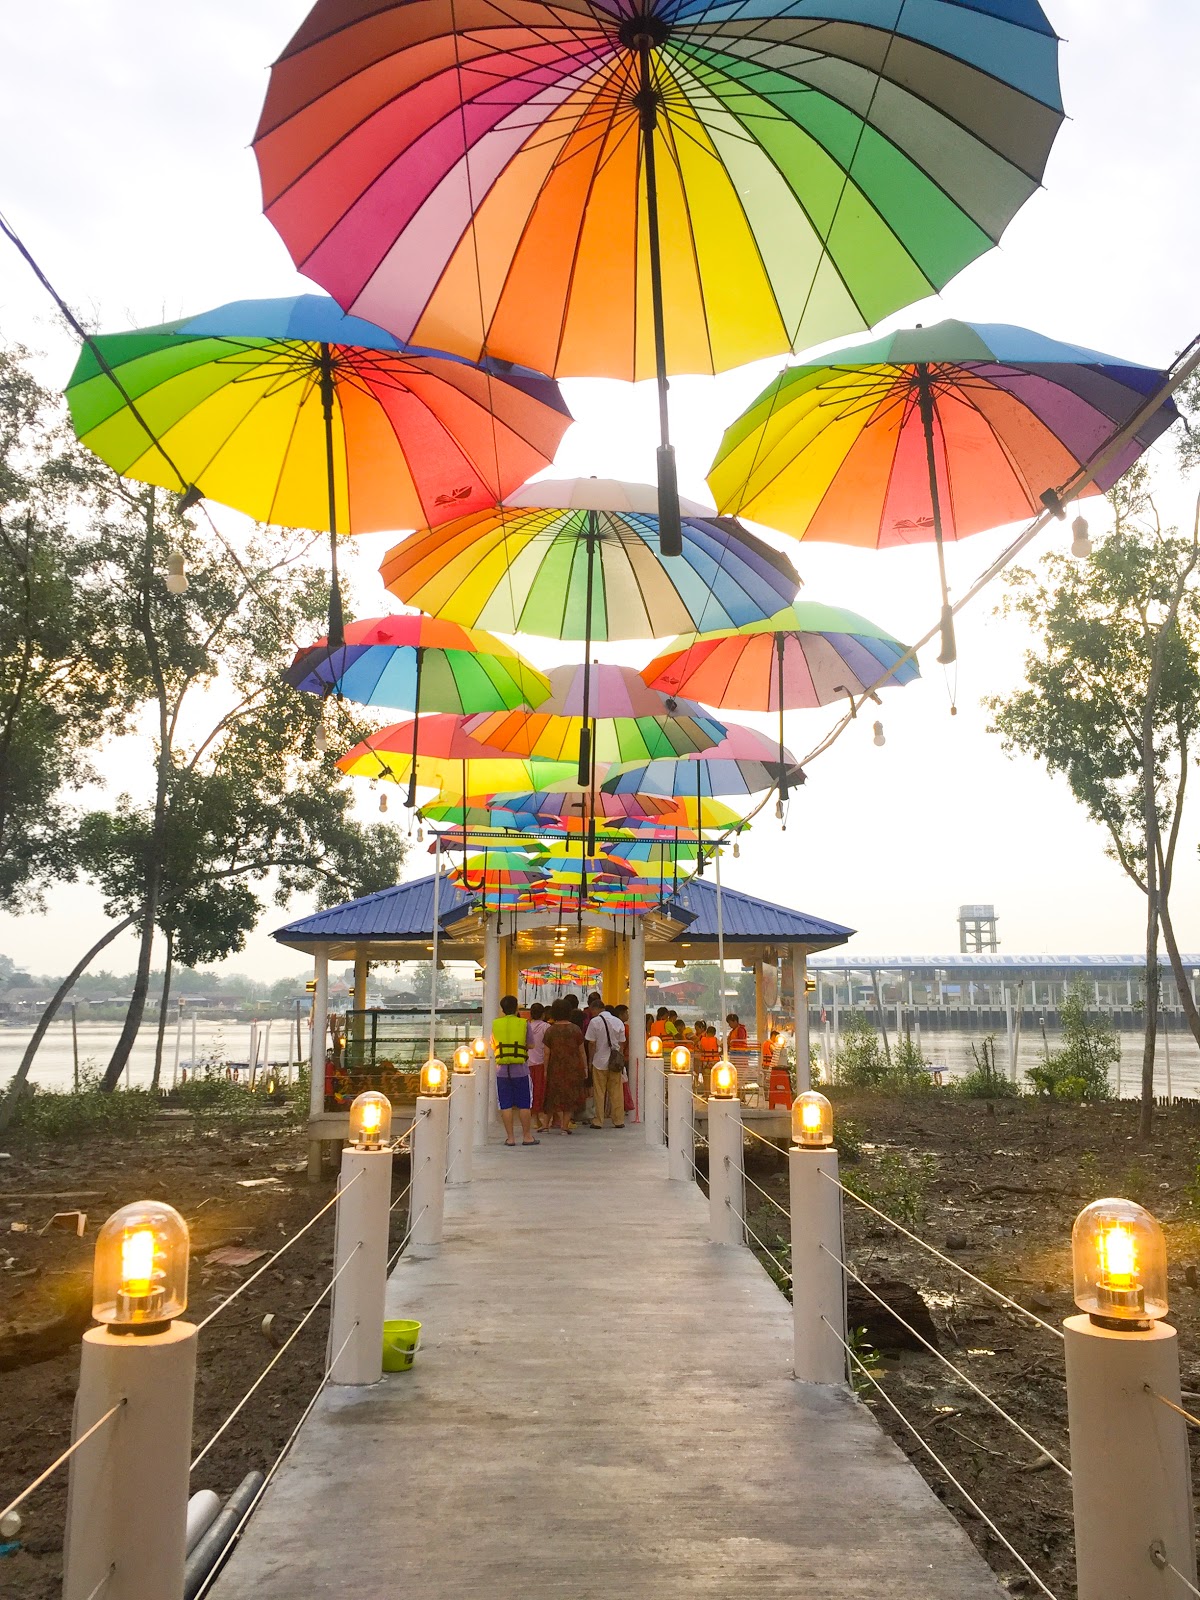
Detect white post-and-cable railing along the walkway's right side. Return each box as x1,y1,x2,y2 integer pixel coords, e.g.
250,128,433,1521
672,1094,1200,1600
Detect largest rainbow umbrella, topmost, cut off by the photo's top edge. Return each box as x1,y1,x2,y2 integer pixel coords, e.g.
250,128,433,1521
254,0,1062,554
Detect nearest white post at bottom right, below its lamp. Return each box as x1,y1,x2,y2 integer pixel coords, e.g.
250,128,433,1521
1062,1315,1197,1600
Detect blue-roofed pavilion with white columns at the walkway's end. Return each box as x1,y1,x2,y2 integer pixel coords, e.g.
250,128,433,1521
274,872,854,1164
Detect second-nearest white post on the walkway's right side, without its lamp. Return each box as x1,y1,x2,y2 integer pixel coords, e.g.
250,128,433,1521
787,1149,846,1384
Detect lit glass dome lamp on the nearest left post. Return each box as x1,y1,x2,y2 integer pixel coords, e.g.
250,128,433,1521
91,1200,190,1334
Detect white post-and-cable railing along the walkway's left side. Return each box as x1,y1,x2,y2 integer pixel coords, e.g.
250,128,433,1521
0,1096,469,1600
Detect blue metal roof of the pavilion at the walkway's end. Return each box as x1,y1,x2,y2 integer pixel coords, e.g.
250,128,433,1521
272,874,854,947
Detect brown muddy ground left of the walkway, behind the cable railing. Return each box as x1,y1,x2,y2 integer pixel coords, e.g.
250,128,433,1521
0,1114,408,1600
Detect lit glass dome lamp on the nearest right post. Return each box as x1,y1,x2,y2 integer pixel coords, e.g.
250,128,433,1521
1070,1198,1168,1333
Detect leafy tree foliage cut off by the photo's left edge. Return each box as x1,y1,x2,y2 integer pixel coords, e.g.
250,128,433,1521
0,346,134,909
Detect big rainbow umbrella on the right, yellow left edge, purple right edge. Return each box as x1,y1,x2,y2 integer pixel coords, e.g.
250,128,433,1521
709,322,1179,661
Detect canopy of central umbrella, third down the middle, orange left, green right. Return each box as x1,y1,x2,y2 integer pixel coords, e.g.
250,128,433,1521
469,662,725,762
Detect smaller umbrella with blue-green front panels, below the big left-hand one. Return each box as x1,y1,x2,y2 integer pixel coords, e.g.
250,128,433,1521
285,616,550,806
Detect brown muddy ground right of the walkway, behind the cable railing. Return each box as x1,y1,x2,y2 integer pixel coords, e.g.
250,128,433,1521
747,1091,1200,1600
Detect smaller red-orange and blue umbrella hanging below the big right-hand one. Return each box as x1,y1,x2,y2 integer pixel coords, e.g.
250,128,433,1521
642,600,920,802
